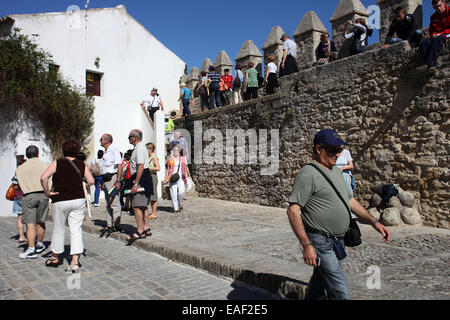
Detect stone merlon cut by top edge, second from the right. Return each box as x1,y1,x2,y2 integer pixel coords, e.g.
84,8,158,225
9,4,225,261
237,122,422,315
330,0,370,51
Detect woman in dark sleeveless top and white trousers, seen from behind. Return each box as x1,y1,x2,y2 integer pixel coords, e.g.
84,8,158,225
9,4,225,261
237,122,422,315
41,140,95,273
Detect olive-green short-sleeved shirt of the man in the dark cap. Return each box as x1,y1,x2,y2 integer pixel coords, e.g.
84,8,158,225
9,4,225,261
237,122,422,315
288,161,353,236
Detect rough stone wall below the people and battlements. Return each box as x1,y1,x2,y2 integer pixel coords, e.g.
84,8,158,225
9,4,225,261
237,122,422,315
176,42,450,228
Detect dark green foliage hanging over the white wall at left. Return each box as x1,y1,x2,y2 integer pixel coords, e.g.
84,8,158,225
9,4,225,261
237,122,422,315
0,29,94,153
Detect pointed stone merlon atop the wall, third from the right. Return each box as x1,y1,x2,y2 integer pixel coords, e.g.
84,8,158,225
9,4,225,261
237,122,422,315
294,11,327,70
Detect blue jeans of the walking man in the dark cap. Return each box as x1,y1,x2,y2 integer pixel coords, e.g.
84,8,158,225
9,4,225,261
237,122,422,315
305,232,350,300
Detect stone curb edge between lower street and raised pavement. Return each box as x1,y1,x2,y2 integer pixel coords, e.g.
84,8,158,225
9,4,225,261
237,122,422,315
49,214,307,300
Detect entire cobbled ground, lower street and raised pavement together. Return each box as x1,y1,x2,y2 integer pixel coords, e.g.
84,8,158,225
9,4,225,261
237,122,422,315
0,195,450,300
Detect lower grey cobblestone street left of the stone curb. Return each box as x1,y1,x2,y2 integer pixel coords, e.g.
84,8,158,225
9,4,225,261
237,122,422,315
0,218,270,300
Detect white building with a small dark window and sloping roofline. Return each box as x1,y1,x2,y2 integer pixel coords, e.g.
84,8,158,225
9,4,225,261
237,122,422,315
0,5,186,215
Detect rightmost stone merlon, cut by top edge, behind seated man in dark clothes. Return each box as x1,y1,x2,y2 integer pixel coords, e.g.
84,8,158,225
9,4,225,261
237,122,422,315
377,0,424,43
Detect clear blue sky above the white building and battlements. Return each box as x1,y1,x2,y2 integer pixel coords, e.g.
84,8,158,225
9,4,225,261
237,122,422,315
0,0,433,70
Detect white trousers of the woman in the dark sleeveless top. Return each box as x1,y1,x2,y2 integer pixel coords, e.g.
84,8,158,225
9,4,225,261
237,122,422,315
52,199,86,255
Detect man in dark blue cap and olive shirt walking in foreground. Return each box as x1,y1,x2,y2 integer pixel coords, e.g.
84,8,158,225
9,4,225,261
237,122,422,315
287,130,391,300
